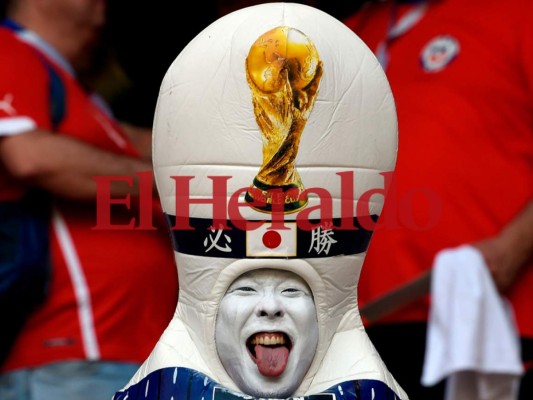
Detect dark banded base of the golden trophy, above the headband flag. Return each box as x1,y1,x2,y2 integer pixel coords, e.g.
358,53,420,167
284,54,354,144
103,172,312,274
244,178,309,214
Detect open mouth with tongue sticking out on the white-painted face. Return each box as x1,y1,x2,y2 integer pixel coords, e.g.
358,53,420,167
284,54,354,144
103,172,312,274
246,332,292,377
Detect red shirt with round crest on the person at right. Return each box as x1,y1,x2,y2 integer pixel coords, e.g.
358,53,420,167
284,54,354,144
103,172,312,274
345,0,533,337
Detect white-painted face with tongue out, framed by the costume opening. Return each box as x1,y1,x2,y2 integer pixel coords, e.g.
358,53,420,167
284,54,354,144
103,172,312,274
215,269,318,398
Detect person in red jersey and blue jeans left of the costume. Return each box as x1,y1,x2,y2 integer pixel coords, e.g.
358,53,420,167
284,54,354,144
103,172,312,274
0,0,178,400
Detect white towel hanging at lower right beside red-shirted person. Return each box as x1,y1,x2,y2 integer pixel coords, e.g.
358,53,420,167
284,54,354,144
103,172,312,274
422,245,523,400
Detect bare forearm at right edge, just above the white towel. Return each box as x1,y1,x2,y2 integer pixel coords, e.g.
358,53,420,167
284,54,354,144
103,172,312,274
474,200,533,293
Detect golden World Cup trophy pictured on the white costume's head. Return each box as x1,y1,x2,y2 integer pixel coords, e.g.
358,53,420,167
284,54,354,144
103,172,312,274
245,26,322,213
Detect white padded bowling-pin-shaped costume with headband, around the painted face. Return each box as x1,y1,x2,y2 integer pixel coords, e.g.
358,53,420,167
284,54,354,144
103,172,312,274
114,3,407,400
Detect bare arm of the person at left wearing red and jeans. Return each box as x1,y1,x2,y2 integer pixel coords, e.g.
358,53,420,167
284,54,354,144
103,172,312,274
0,130,152,200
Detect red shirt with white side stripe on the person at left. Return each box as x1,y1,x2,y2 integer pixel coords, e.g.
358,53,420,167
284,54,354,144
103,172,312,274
0,27,178,370
